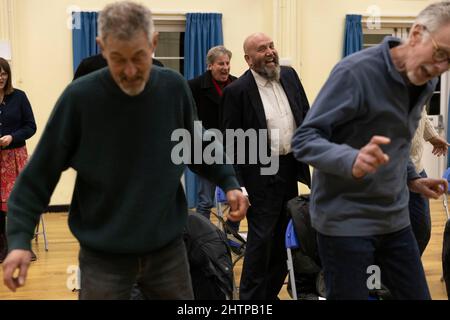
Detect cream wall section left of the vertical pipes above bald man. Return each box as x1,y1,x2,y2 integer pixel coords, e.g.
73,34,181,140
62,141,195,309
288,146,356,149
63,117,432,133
9,0,273,204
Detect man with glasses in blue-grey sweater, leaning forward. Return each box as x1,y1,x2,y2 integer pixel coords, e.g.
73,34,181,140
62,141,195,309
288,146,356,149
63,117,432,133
292,2,450,299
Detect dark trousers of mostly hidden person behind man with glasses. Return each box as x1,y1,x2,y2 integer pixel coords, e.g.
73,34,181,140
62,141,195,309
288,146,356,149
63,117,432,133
409,170,431,255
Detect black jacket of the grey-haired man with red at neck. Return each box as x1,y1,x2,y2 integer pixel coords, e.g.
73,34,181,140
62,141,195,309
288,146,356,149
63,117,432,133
189,70,237,129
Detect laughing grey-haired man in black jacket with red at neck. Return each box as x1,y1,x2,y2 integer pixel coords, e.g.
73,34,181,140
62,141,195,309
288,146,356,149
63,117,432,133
189,46,239,231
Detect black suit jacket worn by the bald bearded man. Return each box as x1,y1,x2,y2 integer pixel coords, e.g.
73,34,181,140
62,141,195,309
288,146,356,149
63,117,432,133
220,67,311,193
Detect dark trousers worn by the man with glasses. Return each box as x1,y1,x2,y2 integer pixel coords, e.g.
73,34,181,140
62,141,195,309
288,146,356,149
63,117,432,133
317,227,431,300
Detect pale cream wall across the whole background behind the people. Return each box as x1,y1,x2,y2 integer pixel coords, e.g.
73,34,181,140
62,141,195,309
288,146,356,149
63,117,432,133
7,0,442,204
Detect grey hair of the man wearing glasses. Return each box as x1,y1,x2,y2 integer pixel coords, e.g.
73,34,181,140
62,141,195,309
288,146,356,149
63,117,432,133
414,1,450,33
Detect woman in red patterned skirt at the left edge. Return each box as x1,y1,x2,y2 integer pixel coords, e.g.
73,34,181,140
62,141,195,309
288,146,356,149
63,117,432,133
0,58,36,262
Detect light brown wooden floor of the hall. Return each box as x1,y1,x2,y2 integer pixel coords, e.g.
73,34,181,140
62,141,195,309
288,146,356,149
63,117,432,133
0,201,447,300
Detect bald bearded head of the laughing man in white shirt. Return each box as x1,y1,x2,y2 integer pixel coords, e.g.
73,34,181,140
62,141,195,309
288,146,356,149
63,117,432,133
244,32,280,80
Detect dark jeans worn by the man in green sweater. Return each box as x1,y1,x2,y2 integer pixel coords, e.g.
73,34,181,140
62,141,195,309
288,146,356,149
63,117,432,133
79,238,194,300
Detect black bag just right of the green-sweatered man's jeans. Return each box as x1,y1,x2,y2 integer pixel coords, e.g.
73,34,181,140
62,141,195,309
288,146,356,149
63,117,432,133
184,214,233,300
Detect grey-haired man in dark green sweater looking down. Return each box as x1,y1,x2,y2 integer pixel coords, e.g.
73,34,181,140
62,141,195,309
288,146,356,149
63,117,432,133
3,2,248,299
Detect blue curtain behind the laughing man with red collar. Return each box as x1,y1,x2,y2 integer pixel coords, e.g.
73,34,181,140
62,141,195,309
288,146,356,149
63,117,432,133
184,13,223,208
